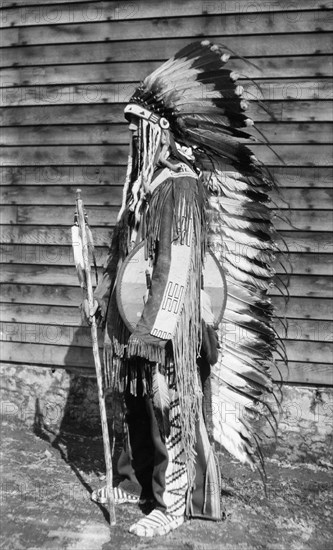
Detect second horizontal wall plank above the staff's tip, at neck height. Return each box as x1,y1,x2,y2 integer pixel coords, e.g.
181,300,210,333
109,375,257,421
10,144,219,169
0,144,333,166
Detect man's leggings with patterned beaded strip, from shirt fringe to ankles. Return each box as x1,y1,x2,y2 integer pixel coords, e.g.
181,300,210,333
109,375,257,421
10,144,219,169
118,366,221,520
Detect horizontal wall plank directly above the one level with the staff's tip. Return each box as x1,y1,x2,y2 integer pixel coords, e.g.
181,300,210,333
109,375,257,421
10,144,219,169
0,165,333,189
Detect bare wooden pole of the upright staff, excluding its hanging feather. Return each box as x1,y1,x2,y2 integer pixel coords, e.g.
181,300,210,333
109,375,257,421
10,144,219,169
76,189,116,529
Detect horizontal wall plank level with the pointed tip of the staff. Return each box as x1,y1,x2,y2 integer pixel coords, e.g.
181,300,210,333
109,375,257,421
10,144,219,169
0,185,333,210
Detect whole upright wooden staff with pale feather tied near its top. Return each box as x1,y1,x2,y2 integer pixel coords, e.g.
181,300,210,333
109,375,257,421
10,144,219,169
72,189,116,528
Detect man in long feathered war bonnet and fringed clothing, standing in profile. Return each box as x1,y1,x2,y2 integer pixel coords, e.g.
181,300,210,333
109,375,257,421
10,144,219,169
85,41,275,536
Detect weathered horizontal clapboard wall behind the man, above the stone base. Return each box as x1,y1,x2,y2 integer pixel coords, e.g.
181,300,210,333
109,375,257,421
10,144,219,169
0,0,333,385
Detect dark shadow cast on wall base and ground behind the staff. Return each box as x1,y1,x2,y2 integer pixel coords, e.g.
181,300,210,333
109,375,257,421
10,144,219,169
33,327,123,490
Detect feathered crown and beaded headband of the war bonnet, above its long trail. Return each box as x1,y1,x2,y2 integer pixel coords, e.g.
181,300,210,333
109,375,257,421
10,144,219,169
124,40,256,179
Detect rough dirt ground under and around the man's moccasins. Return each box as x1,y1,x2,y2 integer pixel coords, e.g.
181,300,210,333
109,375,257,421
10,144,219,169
0,422,333,550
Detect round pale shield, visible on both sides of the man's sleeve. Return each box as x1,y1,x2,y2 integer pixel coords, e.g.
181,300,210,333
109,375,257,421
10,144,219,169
117,242,227,332
